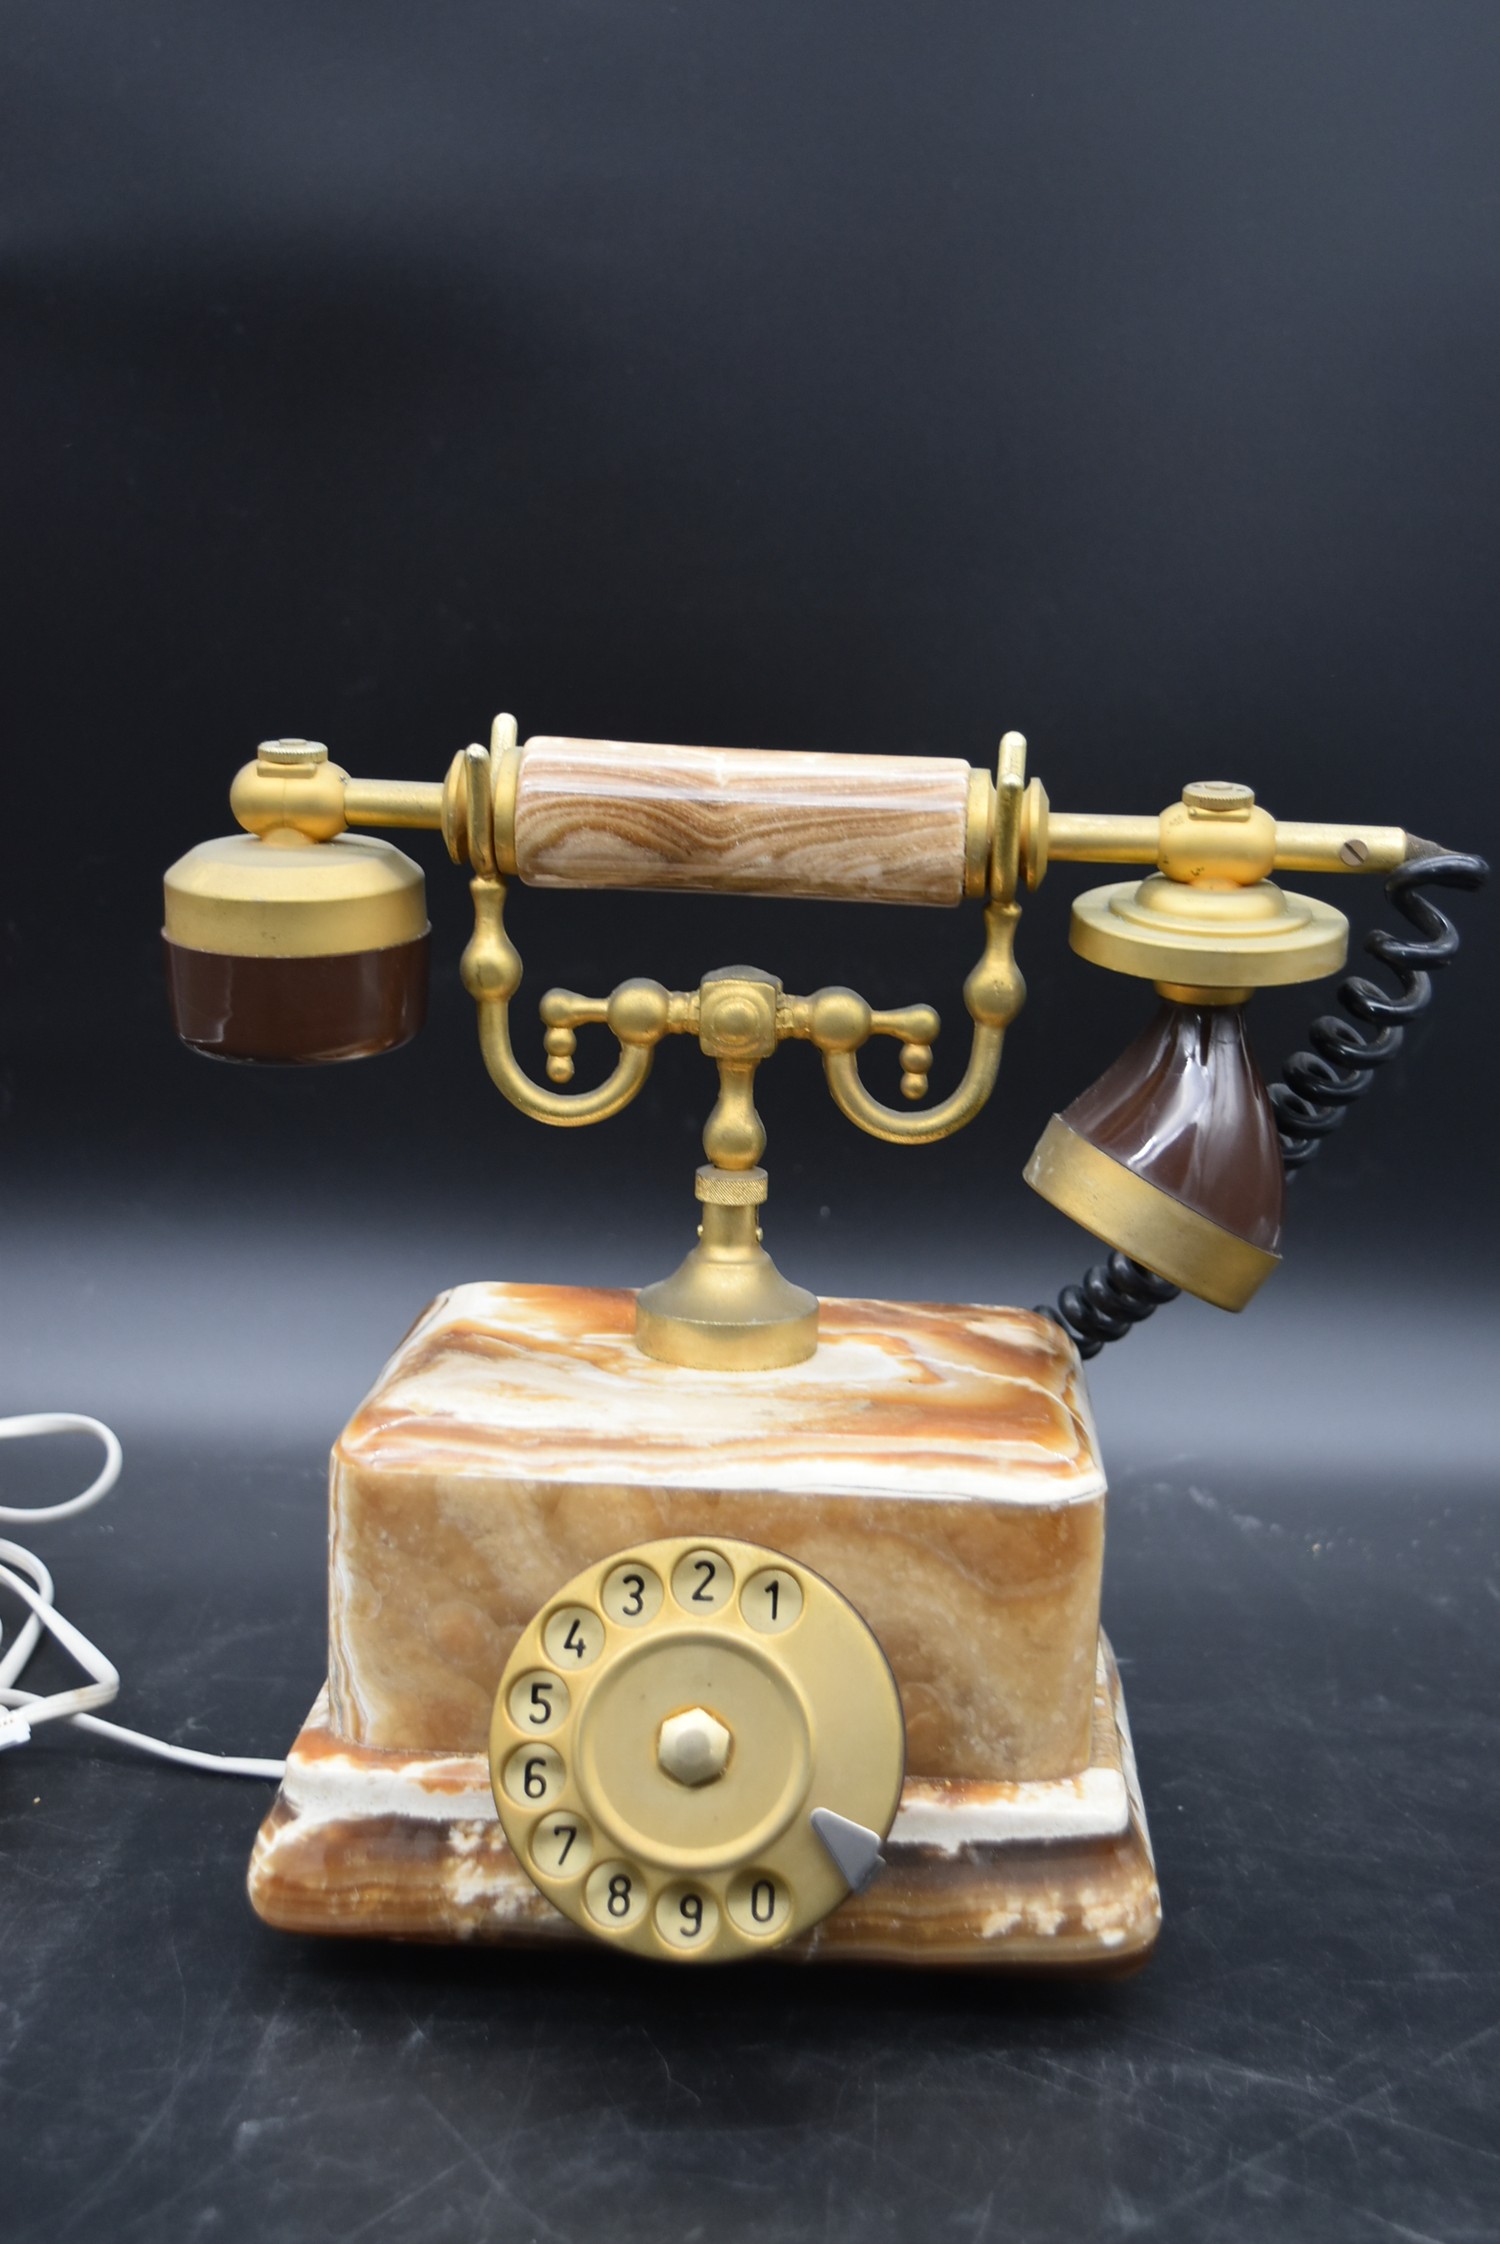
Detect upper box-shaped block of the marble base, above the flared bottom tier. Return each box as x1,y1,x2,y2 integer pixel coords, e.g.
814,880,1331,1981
330,1286,1105,1784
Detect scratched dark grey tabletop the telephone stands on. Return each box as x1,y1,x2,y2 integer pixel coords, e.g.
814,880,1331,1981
0,1438,1500,2244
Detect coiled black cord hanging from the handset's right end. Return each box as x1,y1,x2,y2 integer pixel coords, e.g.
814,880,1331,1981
1037,850,1489,1360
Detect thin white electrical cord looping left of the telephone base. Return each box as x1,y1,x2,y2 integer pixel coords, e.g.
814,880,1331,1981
0,1409,285,1779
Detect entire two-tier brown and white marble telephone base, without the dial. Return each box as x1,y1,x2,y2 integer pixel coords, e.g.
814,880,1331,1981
249,1286,1159,1966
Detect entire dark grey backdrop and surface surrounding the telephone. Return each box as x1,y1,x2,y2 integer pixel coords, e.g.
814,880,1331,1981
0,0,1500,2240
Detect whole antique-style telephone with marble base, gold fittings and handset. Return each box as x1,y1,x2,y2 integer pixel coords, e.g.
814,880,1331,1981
164,718,1484,1964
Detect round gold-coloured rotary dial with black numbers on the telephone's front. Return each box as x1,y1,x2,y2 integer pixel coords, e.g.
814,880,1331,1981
490,1535,905,1964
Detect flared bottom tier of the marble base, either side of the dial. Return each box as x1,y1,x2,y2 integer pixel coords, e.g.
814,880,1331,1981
249,1636,1161,1970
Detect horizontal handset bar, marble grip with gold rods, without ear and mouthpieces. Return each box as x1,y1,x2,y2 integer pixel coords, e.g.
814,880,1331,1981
231,716,1433,904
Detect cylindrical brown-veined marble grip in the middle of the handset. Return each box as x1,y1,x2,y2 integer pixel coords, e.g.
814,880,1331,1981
514,736,970,904
